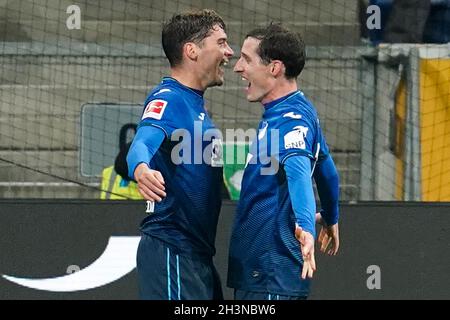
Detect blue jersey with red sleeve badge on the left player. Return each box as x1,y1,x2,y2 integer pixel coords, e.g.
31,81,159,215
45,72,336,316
138,77,223,256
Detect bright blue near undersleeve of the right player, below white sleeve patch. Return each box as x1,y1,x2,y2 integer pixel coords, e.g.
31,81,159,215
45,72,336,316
284,155,316,238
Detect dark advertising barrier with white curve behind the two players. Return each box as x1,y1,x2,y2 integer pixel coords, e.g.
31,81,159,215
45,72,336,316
0,200,450,299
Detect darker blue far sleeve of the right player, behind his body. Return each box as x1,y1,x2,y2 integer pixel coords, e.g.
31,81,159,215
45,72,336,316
314,155,339,226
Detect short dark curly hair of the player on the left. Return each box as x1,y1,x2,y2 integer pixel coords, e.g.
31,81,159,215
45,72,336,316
162,9,225,67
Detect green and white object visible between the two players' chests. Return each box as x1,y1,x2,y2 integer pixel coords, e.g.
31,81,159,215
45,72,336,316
223,142,249,200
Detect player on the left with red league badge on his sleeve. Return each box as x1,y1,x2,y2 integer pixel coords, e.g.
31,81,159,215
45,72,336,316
127,9,233,300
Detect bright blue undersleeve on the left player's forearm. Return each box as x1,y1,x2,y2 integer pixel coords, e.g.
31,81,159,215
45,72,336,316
127,125,166,181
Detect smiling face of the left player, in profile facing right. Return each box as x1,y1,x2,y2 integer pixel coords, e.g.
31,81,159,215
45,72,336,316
198,25,233,88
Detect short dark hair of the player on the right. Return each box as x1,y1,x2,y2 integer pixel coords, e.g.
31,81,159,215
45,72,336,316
245,23,306,79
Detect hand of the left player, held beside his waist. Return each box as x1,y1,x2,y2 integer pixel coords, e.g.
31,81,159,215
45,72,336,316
134,163,166,202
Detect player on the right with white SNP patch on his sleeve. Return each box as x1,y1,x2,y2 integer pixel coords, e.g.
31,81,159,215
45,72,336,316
228,24,339,300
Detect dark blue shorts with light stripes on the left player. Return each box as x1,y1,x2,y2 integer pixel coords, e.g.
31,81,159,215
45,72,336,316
137,234,223,300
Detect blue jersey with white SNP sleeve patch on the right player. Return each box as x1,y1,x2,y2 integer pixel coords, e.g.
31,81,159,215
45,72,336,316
228,91,328,295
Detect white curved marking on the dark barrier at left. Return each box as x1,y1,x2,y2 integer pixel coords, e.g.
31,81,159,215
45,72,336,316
3,237,140,292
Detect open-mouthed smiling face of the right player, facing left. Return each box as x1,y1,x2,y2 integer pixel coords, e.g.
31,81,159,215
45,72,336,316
234,37,275,103
